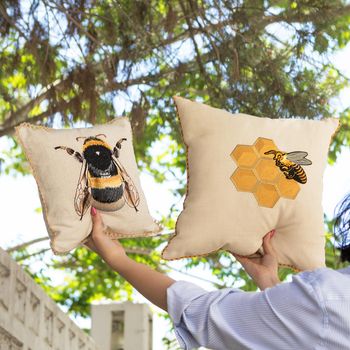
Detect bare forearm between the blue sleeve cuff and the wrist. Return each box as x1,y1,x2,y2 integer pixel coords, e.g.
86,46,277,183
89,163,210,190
107,255,176,311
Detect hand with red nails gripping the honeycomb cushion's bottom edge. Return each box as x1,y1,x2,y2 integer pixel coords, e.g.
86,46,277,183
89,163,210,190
232,230,281,290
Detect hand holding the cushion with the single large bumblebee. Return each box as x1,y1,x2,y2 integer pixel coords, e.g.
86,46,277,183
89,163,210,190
84,207,126,266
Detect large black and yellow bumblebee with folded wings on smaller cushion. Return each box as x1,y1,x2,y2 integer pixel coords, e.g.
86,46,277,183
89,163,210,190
54,134,140,220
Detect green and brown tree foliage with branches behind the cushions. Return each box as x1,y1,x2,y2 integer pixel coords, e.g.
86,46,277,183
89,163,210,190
0,0,350,348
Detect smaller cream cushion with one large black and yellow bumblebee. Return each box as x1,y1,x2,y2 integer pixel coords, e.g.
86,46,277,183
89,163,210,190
16,117,161,254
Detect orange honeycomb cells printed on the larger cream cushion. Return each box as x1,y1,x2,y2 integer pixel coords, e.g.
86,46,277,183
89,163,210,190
231,137,300,208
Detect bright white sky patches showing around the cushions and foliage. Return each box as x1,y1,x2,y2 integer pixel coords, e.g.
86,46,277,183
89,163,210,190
0,34,350,350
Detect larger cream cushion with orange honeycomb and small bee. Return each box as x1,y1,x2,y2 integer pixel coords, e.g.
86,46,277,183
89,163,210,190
162,96,338,271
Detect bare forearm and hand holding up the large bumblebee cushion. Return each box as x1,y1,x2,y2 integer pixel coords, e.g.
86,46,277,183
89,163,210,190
85,208,176,311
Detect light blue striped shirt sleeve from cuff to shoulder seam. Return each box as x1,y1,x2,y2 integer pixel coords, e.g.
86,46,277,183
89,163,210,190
167,273,324,350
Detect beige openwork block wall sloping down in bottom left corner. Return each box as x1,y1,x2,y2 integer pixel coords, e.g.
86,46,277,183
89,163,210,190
0,248,99,350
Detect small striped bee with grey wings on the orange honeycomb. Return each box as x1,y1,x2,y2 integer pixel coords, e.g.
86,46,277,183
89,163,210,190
264,149,312,184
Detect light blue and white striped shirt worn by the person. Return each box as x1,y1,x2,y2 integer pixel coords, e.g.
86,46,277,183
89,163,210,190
167,266,350,350
